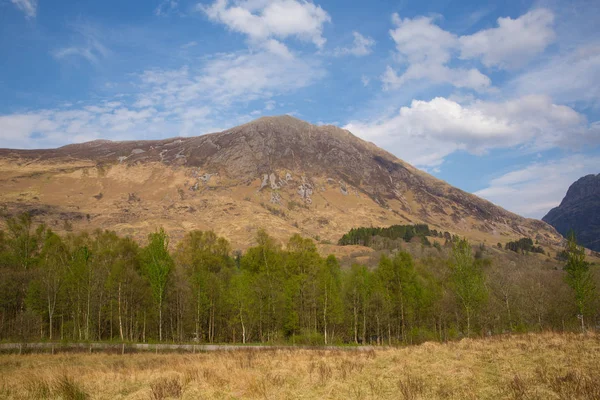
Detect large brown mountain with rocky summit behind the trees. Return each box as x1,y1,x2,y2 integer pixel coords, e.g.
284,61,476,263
0,116,561,248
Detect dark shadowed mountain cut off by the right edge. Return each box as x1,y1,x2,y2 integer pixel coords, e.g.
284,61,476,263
542,174,600,251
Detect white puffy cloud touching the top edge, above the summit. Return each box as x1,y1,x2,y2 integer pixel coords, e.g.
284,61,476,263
202,0,331,48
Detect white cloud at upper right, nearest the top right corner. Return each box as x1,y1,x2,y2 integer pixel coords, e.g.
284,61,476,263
459,8,555,69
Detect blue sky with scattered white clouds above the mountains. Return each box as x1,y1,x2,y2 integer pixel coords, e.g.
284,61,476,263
0,0,600,218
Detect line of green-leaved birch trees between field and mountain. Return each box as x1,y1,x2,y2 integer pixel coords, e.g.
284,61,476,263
0,214,600,344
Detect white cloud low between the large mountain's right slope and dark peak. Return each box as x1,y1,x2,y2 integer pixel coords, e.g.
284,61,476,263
474,154,600,218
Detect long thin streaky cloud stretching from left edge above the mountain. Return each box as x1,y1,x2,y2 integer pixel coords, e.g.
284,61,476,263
0,51,324,148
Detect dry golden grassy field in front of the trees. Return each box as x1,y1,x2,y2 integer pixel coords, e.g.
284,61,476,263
0,333,600,399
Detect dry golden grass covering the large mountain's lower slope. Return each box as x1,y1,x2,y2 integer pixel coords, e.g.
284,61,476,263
0,156,560,252
